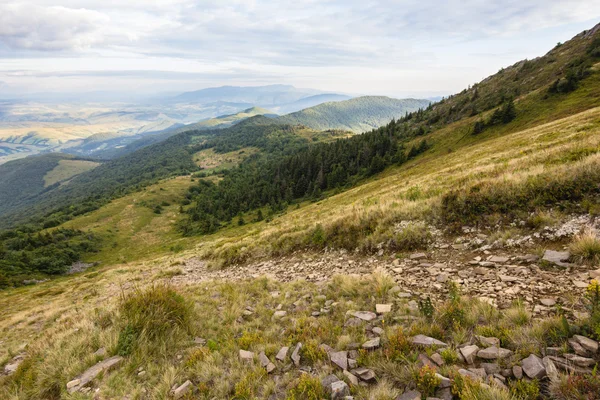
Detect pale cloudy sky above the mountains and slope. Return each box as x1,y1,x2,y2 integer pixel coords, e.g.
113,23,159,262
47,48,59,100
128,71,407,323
0,0,600,97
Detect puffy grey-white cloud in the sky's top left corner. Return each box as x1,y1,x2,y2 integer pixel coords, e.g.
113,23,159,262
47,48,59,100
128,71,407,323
0,3,109,51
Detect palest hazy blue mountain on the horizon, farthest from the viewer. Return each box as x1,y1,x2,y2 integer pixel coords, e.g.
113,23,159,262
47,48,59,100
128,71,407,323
171,85,321,108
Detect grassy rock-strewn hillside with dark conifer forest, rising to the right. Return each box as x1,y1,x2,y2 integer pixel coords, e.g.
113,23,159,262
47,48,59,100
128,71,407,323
0,25,600,400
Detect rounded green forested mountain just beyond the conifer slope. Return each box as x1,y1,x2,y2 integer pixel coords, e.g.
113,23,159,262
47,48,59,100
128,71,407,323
278,96,430,133
